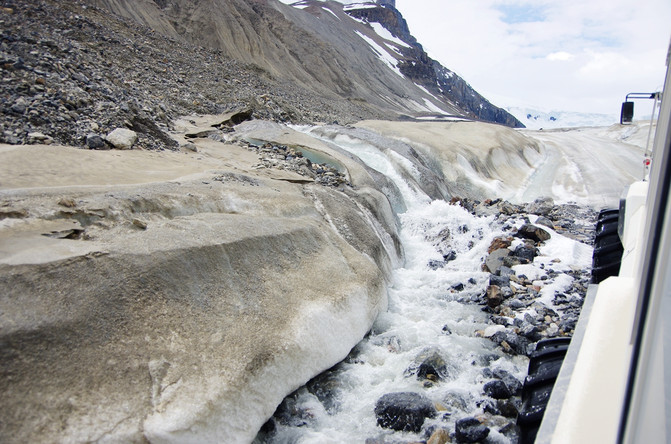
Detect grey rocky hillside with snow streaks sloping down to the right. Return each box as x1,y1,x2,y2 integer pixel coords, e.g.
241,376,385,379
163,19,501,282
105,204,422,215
0,0,520,148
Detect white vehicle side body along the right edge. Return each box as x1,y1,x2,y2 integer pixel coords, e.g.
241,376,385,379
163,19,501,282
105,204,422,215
536,40,671,444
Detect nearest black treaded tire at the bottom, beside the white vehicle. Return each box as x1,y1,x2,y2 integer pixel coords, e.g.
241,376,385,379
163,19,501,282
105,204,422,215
517,337,571,444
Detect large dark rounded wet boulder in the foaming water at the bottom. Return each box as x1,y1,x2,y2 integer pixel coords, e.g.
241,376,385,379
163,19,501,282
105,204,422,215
375,392,437,433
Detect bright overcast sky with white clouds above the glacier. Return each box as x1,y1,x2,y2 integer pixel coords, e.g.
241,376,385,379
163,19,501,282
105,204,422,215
396,0,671,115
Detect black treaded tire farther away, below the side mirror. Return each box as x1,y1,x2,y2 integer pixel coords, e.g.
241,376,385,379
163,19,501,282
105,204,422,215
592,210,624,284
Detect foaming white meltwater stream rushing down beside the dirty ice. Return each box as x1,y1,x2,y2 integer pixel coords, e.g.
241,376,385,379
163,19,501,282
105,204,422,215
256,126,527,443
